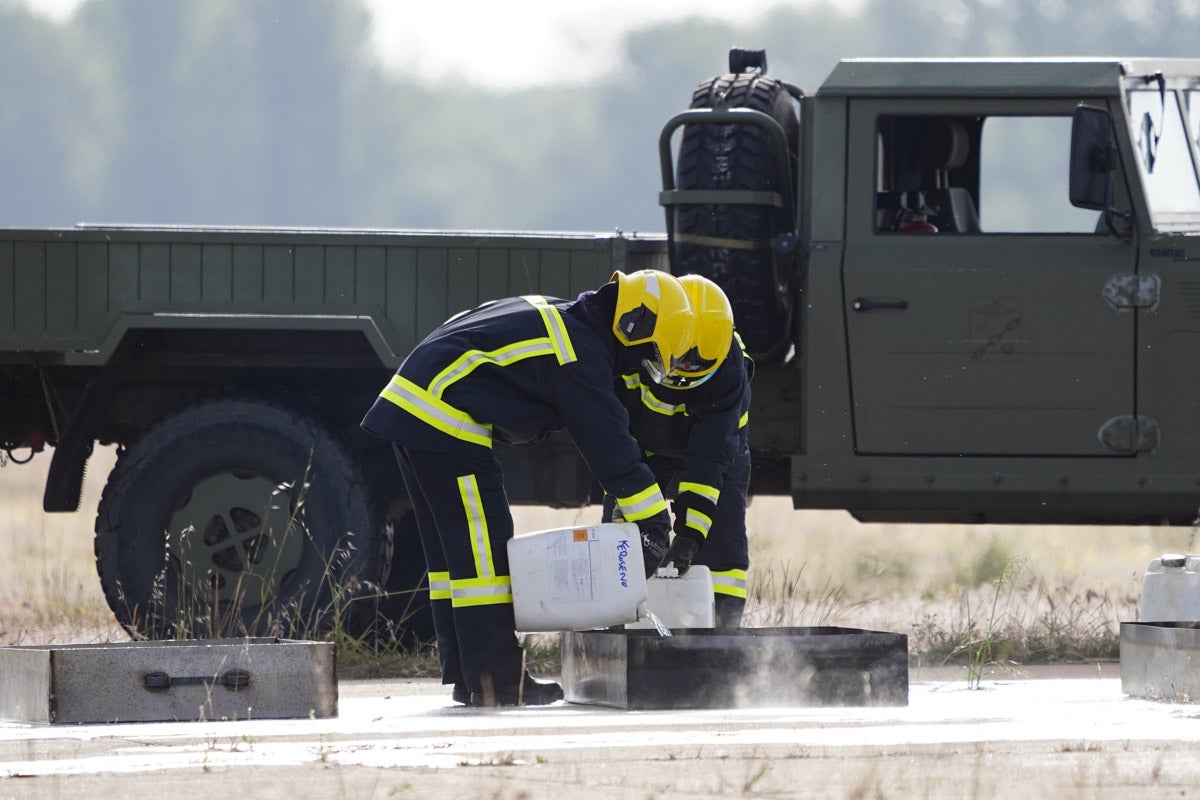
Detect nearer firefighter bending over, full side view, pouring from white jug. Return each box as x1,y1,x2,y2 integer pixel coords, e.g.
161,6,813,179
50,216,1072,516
362,270,696,705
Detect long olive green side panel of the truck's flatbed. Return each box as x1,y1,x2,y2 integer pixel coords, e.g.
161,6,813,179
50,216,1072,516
0,229,666,366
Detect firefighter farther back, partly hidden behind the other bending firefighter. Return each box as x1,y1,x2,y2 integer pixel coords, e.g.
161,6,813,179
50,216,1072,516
604,275,754,630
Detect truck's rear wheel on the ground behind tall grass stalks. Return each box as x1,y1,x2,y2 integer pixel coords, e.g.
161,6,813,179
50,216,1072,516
96,399,388,638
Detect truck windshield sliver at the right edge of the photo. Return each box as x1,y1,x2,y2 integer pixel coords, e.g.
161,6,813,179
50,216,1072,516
1128,89,1200,229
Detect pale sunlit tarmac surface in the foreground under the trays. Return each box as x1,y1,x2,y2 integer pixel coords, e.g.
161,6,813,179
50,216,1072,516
0,663,1200,800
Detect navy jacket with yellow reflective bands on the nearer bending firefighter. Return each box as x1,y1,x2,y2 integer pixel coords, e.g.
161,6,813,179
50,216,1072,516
362,283,666,522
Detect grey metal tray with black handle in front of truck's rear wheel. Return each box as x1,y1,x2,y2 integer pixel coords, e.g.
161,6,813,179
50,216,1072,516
0,638,337,723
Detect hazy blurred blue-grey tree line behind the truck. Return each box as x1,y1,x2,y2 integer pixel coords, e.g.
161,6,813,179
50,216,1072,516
0,0,1200,230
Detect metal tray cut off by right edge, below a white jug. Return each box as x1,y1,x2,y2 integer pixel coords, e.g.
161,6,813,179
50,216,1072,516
1121,621,1200,703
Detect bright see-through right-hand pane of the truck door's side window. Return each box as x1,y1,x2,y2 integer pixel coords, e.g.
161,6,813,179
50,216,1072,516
979,116,1097,234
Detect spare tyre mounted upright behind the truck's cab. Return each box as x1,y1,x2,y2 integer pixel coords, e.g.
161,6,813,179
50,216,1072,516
672,72,799,362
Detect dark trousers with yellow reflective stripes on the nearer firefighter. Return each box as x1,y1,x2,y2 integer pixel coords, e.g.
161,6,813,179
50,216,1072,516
395,446,523,693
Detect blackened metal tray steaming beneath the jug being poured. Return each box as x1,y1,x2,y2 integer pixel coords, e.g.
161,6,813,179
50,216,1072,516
563,627,908,709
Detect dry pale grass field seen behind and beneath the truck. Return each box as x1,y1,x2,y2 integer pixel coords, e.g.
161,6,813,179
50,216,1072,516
0,443,1198,663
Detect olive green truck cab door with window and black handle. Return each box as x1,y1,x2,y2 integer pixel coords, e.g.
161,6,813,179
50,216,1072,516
844,100,1138,456
